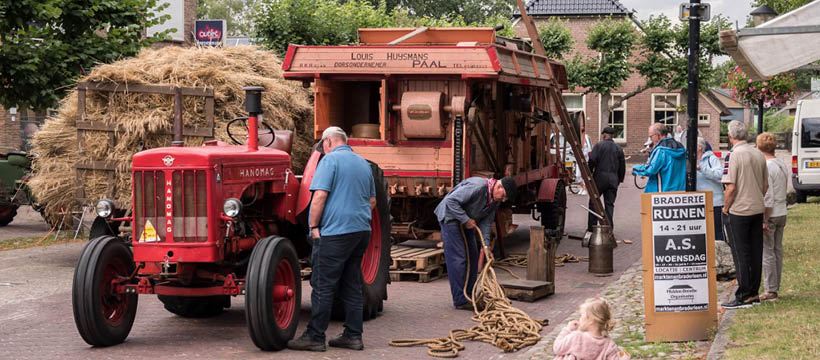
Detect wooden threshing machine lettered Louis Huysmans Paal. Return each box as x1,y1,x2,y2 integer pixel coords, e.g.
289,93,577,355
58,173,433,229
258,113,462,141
282,28,578,251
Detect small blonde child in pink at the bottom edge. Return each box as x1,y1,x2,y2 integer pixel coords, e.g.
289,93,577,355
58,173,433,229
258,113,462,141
552,296,630,360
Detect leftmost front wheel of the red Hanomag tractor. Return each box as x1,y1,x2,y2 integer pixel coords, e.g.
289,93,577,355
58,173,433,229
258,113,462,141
71,236,137,346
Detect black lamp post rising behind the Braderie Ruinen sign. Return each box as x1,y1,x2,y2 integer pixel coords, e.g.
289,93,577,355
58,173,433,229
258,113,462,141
686,0,701,191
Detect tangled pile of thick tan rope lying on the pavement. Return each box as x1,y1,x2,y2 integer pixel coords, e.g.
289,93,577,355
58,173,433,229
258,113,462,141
389,229,548,358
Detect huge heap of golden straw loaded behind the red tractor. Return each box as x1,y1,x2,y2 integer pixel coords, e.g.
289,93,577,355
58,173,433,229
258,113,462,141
29,46,313,221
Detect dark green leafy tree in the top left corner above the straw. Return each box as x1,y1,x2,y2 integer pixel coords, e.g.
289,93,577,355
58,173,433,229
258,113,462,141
0,0,168,110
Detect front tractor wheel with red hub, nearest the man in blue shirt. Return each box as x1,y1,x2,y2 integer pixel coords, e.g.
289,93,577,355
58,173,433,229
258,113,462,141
245,236,302,350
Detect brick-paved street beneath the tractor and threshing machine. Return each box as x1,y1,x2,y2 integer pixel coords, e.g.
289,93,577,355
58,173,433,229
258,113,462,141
0,184,641,359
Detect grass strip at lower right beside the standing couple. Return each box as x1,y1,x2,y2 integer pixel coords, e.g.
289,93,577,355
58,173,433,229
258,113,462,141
725,202,820,359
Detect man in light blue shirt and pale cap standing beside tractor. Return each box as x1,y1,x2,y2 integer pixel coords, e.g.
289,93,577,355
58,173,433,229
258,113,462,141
288,126,376,351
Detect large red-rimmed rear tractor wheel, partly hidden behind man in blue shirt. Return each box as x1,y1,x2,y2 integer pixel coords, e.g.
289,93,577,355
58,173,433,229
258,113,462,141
331,162,393,321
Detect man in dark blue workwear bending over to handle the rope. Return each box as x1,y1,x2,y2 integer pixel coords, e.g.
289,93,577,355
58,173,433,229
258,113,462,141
435,177,517,310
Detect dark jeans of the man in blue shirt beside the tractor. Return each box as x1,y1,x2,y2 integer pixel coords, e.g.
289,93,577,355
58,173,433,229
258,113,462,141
307,231,370,341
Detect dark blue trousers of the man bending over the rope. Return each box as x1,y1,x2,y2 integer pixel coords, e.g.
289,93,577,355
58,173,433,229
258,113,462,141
439,222,479,306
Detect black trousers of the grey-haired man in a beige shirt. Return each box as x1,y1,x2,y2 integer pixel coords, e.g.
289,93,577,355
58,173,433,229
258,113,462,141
723,214,763,302
